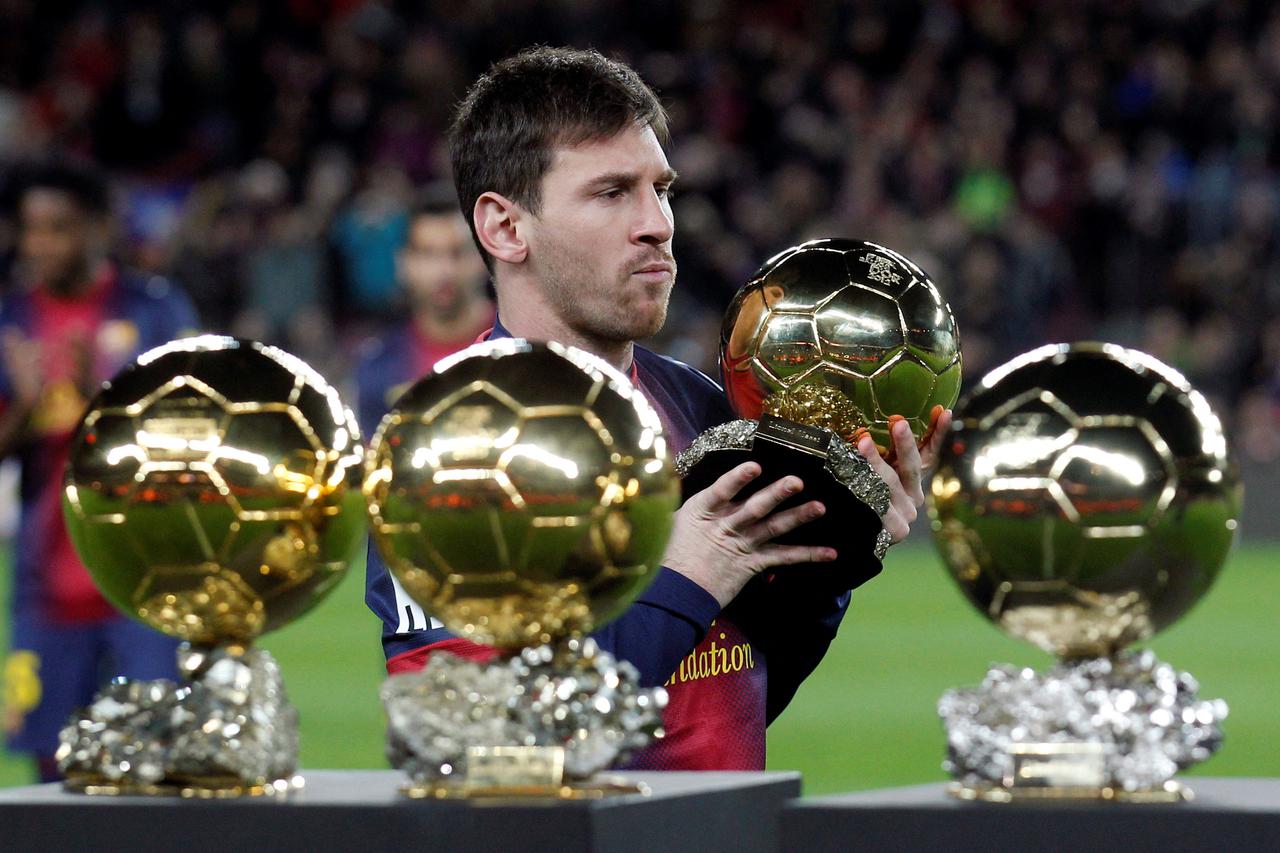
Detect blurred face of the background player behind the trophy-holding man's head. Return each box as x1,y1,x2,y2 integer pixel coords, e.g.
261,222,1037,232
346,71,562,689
398,214,485,314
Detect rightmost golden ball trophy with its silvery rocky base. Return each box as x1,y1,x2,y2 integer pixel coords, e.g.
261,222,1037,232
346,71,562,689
929,343,1240,802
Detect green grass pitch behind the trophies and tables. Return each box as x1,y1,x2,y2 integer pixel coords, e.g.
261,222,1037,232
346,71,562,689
0,542,1280,794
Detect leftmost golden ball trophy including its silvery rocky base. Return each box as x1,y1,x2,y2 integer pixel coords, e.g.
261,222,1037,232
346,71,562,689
58,336,365,797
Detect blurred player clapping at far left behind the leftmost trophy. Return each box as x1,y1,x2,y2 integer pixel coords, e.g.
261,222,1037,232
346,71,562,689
0,162,196,781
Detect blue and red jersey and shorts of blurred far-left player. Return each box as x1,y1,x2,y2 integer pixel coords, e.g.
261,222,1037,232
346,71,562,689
0,265,196,756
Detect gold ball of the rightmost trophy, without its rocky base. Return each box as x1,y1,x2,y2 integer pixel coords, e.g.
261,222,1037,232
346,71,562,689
929,343,1240,657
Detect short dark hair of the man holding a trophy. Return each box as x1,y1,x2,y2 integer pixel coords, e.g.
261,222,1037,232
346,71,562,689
449,46,668,272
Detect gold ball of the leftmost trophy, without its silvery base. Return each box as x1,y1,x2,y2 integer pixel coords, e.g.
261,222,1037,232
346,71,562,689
63,336,365,646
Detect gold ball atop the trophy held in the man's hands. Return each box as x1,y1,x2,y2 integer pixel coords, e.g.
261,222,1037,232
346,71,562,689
721,238,960,448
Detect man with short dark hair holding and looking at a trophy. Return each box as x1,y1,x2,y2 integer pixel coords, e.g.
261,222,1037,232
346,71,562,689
367,47,950,770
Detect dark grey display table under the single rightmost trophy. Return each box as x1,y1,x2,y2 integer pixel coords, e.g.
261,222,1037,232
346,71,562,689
782,777,1280,853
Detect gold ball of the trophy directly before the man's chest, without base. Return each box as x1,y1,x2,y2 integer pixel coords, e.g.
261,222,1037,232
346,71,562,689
365,338,680,648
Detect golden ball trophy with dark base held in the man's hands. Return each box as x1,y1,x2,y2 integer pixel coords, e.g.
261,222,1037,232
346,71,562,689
676,238,960,594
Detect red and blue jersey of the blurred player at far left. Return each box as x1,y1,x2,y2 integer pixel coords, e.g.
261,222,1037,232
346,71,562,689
0,266,196,625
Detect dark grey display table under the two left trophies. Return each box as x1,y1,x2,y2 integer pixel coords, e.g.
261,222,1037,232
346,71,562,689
0,770,800,853
